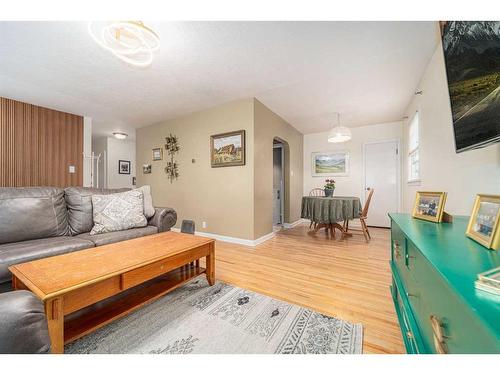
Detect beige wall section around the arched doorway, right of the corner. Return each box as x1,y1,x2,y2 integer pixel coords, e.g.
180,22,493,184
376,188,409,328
254,99,303,238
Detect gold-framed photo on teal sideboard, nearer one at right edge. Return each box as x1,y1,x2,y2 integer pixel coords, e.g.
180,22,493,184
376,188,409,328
465,194,500,250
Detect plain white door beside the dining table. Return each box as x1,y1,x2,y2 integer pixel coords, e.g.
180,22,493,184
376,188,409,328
364,141,400,227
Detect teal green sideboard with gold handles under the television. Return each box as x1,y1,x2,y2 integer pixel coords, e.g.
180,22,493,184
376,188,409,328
389,214,500,353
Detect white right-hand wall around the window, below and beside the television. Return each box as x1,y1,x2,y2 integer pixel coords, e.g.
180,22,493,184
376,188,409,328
403,43,500,215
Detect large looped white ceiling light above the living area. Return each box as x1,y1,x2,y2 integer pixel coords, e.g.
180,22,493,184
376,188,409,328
88,21,160,67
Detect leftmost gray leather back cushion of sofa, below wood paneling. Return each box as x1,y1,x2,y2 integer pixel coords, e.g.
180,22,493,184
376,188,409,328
0,187,69,244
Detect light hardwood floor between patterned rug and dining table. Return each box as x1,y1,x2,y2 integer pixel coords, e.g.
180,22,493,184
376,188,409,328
209,224,404,353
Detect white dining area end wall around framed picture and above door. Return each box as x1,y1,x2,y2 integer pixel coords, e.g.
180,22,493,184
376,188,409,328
304,122,402,204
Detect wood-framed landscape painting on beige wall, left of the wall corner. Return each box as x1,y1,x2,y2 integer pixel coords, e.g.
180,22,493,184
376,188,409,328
210,130,246,168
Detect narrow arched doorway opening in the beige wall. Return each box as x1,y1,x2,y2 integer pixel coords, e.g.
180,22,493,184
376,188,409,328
273,139,285,226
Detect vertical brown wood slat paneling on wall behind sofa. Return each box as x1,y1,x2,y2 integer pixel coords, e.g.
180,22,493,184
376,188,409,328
0,98,83,187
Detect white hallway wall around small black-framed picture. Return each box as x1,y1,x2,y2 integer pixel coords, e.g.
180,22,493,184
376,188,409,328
92,137,136,189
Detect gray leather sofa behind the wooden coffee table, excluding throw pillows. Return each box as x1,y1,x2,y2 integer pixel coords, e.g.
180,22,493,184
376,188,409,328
0,187,177,292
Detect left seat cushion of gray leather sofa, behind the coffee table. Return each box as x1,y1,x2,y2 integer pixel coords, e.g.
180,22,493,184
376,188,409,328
0,237,94,282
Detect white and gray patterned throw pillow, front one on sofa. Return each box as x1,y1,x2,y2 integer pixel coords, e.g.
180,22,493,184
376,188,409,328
90,190,147,234
